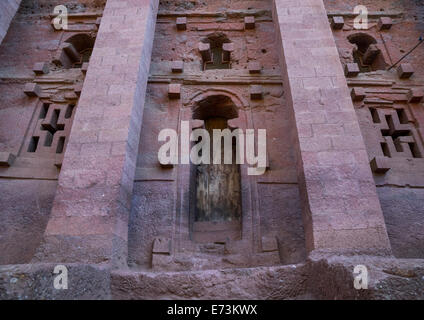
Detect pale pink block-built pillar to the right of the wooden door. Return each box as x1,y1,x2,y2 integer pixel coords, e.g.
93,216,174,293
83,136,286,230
273,0,391,254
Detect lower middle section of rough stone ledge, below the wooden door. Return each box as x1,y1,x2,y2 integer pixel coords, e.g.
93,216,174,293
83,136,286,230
111,265,306,300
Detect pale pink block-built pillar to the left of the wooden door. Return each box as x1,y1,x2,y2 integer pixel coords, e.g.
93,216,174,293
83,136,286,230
35,0,159,266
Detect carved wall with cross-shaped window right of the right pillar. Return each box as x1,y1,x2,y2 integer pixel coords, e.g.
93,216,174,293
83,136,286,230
326,1,424,258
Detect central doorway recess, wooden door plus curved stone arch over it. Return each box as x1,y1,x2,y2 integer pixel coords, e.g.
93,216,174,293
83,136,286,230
187,88,250,243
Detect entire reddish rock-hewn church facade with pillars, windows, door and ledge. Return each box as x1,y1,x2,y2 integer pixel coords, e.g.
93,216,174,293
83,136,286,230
0,0,424,299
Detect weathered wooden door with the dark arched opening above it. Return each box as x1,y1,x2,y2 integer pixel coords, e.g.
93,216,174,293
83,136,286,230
190,95,242,243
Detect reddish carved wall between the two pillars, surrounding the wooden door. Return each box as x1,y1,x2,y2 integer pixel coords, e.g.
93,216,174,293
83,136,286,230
129,1,305,271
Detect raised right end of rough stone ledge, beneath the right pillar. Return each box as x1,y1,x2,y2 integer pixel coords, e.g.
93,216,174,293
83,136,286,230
307,252,424,300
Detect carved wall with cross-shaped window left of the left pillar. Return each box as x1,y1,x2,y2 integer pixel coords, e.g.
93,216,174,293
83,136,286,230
0,0,102,264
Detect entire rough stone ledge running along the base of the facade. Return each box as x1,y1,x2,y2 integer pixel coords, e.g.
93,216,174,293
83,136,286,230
0,251,424,300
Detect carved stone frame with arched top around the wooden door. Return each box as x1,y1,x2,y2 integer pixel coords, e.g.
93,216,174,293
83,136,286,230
173,87,260,253
